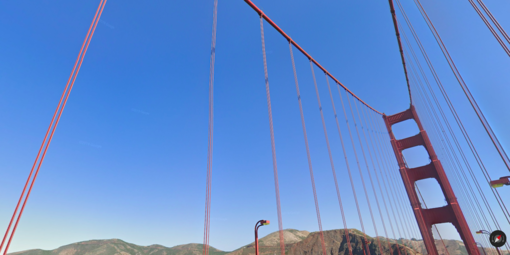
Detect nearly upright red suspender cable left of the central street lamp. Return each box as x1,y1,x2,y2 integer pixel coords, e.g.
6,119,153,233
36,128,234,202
203,0,218,255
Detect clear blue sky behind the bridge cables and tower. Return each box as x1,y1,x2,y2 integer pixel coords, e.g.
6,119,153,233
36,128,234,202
0,0,510,252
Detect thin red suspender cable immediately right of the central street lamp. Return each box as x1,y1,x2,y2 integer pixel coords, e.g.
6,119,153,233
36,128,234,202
260,16,285,255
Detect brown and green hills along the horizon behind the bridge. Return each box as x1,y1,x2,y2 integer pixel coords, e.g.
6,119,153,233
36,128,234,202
8,229,510,255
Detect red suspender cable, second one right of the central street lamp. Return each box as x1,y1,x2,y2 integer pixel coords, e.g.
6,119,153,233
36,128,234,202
289,41,326,255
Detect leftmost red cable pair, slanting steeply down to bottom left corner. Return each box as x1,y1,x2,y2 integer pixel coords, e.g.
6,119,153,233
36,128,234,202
0,0,107,255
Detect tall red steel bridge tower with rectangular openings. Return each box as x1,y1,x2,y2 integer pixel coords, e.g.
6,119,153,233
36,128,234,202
383,105,480,255
